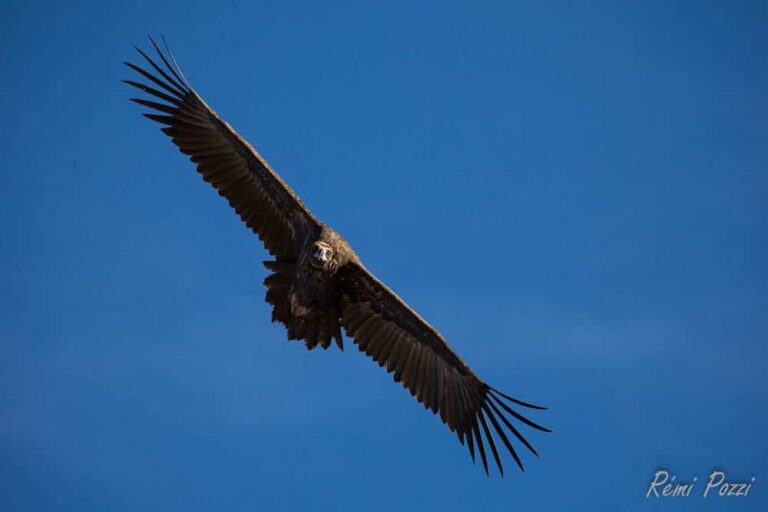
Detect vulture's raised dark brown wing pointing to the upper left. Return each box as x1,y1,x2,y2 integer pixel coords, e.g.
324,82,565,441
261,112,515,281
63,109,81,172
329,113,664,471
124,37,320,260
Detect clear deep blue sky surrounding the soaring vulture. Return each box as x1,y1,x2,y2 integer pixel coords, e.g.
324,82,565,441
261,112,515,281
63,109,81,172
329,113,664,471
0,1,768,512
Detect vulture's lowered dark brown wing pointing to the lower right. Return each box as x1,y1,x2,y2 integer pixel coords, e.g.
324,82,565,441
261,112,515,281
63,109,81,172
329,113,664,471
340,261,550,475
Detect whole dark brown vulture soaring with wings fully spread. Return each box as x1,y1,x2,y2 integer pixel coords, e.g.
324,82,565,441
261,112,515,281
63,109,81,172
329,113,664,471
124,37,551,476
